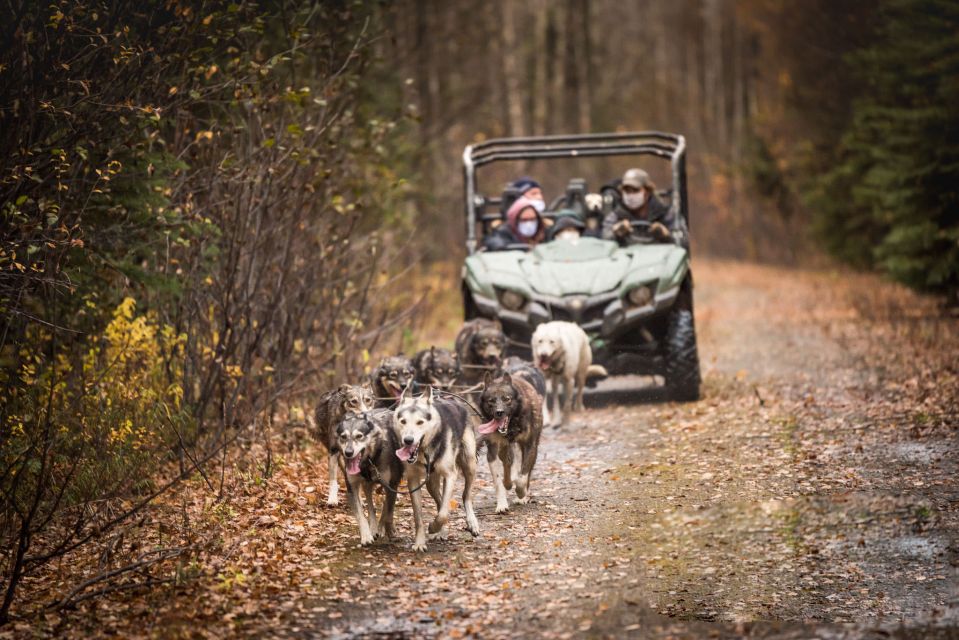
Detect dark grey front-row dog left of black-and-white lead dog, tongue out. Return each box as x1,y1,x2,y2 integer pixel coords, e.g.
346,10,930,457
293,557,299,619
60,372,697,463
336,409,403,546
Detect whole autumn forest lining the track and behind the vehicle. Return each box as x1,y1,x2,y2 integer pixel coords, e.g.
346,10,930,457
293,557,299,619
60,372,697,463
0,0,959,623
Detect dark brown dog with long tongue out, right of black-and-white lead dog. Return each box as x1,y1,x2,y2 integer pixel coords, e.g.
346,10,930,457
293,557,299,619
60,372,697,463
477,372,543,513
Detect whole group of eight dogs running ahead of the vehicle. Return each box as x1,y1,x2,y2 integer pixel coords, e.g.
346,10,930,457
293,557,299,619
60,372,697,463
314,318,603,551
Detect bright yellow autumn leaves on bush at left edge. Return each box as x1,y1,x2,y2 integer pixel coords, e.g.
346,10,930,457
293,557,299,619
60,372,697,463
0,298,189,488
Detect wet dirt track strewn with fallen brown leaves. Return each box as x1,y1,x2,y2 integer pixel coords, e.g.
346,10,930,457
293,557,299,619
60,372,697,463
270,262,959,638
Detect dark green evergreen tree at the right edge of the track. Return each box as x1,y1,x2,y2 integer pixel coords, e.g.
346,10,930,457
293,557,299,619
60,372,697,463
814,0,959,301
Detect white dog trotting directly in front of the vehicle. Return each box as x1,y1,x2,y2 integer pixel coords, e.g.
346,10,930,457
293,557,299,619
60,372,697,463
531,321,606,427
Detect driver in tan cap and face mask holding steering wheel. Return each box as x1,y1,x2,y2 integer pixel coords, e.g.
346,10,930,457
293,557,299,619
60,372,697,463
602,169,675,246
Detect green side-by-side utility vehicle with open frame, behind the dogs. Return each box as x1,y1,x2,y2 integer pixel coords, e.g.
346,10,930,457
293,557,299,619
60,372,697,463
463,132,700,400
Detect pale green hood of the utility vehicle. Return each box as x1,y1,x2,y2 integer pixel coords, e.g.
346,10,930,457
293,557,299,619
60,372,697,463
465,238,686,297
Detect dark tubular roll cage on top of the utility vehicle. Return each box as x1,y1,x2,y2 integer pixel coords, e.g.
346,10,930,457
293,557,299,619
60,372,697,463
463,131,689,255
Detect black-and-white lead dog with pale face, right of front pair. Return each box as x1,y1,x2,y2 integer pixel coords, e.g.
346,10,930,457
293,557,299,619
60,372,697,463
393,387,479,551
